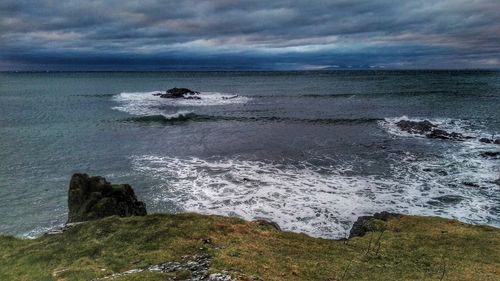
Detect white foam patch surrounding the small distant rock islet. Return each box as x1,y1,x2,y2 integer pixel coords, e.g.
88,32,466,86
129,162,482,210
113,91,250,115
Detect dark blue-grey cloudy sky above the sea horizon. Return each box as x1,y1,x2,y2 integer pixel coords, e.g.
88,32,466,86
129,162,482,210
0,0,500,70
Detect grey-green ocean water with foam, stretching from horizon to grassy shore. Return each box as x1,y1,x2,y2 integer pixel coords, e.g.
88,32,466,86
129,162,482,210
0,71,500,238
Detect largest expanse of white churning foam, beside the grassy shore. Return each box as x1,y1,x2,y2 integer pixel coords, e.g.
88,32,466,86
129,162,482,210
132,154,498,238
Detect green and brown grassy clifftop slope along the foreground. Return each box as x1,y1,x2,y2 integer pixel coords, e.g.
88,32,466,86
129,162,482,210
0,214,500,281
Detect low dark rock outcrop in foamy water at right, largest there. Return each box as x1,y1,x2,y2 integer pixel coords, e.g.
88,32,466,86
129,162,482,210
396,120,470,140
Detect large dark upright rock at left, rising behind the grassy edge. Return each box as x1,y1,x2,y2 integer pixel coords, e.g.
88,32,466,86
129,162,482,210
68,174,146,223
